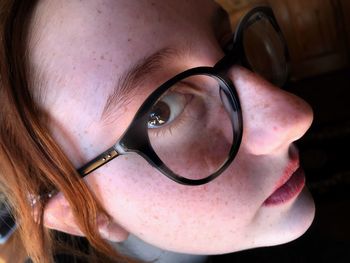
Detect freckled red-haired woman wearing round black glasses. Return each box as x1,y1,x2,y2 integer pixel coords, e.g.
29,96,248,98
0,0,314,262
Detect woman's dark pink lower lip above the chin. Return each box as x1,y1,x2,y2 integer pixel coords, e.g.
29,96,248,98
263,167,305,206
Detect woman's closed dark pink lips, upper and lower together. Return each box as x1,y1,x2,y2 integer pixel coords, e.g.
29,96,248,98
263,146,305,206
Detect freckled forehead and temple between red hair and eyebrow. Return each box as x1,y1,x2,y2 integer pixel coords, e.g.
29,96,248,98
28,0,218,161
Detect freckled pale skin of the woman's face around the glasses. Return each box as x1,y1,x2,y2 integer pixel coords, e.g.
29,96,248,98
30,0,314,254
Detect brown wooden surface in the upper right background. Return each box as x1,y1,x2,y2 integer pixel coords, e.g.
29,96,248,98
218,0,350,80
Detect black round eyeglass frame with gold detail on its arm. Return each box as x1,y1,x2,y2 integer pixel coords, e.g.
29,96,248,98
78,4,289,185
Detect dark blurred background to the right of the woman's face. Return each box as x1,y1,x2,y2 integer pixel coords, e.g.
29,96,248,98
217,0,350,263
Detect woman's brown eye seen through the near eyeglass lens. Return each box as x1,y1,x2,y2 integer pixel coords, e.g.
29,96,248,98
148,92,187,129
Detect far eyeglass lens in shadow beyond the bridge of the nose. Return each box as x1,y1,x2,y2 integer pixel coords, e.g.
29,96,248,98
243,12,288,86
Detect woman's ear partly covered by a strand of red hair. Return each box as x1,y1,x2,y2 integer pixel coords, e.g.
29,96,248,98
44,193,129,242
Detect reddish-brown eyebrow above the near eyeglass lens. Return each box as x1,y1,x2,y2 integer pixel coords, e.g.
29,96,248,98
101,47,186,120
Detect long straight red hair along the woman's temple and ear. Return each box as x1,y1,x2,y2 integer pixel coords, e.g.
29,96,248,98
0,0,139,263
